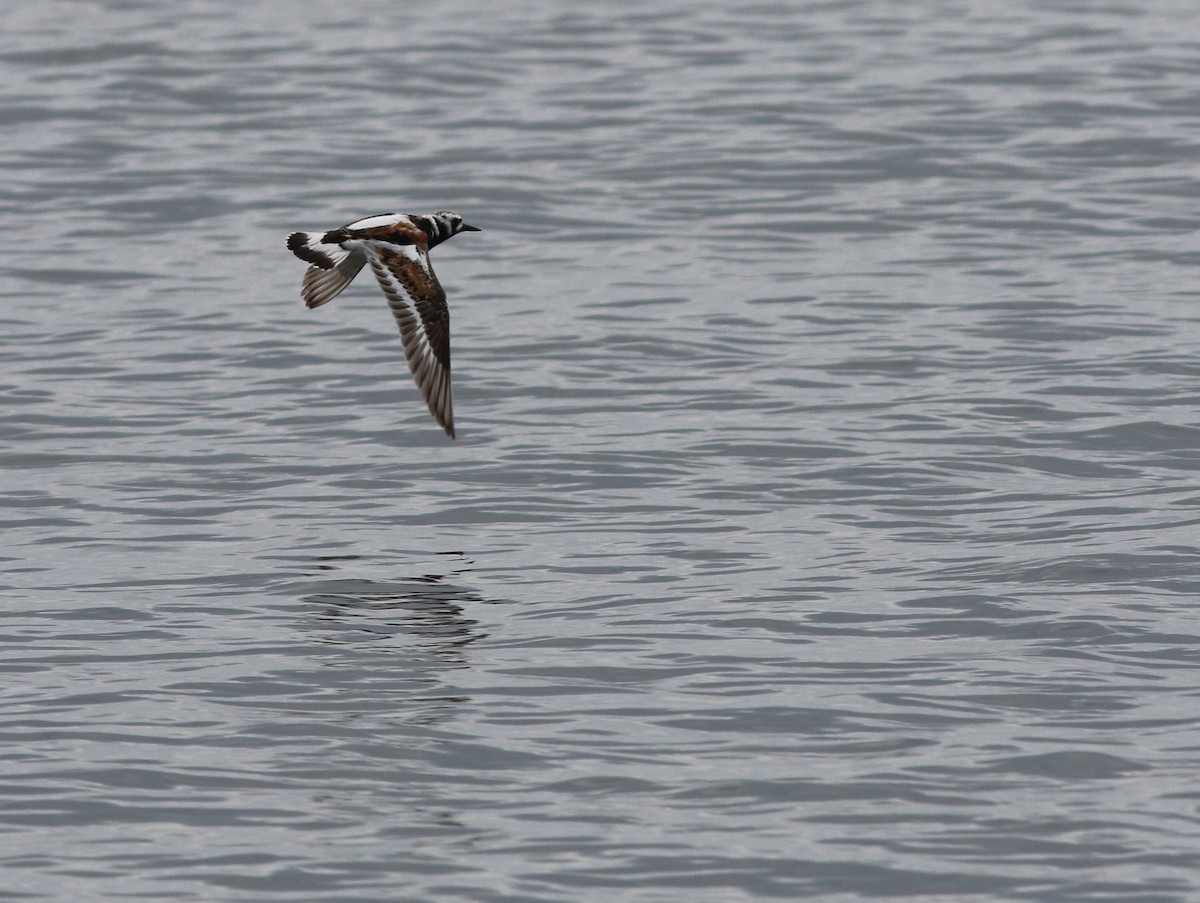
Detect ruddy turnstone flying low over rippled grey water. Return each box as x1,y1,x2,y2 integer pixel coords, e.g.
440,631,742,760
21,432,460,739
288,210,479,438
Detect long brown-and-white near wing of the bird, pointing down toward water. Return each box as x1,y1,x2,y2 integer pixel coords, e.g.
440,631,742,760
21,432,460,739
359,238,454,438
